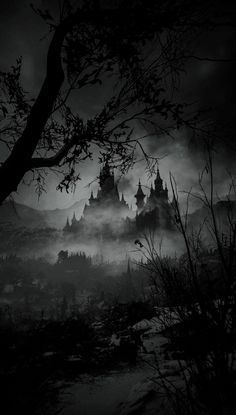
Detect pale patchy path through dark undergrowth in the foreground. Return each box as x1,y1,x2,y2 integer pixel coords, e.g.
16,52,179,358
45,320,187,415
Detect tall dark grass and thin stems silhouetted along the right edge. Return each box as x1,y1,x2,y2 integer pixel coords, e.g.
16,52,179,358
138,145,236,415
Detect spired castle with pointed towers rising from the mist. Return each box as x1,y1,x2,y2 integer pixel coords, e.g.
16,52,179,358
63,163,173,239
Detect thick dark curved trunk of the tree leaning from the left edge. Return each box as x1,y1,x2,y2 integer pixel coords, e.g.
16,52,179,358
0,17,72,204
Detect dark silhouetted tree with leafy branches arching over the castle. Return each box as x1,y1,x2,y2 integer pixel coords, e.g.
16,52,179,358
0,0,232,203
